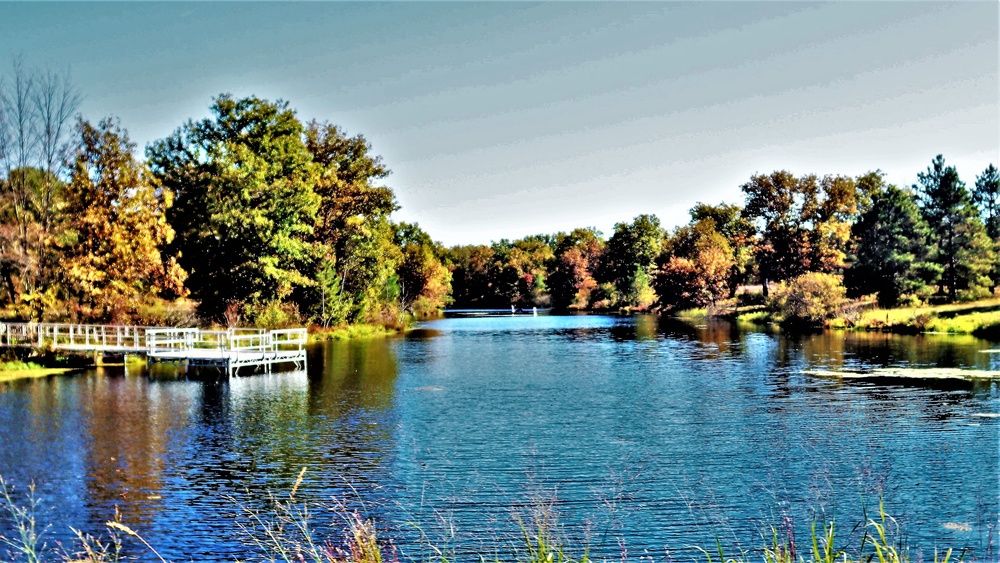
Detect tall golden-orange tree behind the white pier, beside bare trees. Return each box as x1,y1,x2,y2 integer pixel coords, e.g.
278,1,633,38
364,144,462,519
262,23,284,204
64,119,186,322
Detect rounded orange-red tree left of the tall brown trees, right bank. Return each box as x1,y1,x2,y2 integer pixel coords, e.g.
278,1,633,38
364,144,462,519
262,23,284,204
655,219,735,309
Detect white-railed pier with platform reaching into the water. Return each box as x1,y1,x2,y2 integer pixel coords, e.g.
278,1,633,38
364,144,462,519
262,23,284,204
0,323,307,376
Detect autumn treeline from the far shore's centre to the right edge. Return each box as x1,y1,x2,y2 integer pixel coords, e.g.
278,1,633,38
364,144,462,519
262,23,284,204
446,155,1000,320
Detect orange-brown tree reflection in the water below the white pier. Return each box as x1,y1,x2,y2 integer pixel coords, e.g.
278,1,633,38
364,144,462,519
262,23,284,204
79,369,189,527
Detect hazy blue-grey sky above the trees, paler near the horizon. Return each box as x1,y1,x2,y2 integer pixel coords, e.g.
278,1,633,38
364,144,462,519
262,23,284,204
0,0,1000,245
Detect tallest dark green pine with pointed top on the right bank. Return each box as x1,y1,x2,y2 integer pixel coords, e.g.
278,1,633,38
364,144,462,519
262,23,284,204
913,155,996,301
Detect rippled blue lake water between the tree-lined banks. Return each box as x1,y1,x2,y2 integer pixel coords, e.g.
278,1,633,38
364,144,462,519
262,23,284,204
0,315,1000,561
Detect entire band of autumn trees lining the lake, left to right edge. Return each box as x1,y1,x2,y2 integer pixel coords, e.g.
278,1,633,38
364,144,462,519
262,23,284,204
0,64,1000,328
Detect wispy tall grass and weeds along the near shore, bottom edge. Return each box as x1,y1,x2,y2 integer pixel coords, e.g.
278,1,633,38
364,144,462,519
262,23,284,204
0,476,989,563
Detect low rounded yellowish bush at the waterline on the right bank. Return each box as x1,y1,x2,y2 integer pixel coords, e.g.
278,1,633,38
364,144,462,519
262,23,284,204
768,272,845,325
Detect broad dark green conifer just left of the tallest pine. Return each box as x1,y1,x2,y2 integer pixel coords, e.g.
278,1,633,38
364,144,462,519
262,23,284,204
844,186,941,307
